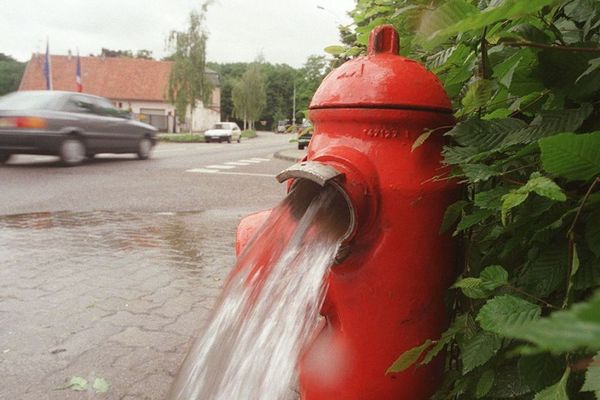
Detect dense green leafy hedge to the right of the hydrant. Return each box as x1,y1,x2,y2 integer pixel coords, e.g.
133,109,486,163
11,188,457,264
340,0,600,400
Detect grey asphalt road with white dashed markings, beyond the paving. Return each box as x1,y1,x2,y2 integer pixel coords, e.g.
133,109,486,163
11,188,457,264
0,132,293,215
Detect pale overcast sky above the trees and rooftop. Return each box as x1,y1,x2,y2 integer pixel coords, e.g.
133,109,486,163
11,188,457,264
0,0,354,67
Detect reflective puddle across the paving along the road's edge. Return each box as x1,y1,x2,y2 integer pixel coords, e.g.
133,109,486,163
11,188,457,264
0,211,242,277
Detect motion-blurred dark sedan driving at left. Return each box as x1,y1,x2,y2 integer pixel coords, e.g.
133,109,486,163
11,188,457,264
0,91,157,166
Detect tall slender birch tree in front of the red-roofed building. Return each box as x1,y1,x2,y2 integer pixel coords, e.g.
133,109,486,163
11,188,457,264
167,1,212,132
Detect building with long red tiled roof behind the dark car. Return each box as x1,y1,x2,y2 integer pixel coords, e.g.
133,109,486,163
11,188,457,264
19,54,220,131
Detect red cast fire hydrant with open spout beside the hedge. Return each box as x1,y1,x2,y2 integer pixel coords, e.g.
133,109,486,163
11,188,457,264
238,26,456,400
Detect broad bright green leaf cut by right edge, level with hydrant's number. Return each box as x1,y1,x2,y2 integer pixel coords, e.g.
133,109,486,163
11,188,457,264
539,132,600,180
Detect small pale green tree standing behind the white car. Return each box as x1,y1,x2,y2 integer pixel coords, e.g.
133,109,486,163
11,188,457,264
231,62,267,130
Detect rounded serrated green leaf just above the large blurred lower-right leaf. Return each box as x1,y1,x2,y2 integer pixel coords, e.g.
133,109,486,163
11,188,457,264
476,295,541,336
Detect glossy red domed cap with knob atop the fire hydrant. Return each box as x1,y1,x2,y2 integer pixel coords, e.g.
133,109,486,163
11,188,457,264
310,25,452,113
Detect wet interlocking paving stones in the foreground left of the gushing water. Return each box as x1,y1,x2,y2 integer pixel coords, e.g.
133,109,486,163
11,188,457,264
0,210,246,400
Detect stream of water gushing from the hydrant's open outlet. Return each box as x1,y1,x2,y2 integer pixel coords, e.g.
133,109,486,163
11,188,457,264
169,182,349,400
